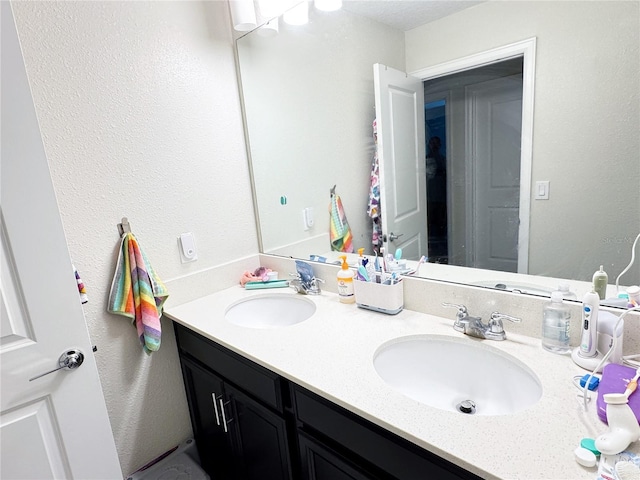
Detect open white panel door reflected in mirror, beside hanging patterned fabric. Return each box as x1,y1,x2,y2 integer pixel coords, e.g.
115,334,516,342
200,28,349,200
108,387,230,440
373,64,428,260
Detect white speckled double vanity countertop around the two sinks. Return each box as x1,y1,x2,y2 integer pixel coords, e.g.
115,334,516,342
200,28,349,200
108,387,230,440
165,286,640,480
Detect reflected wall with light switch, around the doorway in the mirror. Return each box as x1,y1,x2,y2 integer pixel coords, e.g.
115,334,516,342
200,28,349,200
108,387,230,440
406,1,640,285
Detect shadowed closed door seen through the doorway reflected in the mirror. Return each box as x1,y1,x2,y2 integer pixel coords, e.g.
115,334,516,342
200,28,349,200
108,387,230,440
467,75,528,272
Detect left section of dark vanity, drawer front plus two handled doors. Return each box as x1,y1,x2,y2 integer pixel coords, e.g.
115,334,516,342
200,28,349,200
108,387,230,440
176,326,293,480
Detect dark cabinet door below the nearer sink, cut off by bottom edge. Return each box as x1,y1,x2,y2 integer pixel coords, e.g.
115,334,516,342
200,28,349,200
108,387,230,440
298,431,379,480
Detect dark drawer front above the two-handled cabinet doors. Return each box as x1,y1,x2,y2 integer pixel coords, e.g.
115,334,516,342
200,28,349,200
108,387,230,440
174,322,283,412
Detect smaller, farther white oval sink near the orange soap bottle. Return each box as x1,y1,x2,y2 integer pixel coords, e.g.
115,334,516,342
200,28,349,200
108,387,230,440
224,294,316,328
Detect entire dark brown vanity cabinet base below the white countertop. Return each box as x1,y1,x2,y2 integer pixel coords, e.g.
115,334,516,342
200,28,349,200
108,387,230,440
175,323,480,480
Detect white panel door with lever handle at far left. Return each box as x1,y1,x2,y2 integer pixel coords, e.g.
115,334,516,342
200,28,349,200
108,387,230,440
0,1,122,480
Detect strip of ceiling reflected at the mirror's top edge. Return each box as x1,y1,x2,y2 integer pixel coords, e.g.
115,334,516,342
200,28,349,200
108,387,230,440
342,0,485,32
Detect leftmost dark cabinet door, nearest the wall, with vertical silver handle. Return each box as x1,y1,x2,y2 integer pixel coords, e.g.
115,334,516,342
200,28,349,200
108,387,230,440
181,357,234,479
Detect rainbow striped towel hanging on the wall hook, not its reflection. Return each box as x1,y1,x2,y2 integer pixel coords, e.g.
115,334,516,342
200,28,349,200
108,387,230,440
107,233,169,354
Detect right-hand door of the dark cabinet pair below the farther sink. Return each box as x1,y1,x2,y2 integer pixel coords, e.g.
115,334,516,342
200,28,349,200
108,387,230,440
225,384,291,480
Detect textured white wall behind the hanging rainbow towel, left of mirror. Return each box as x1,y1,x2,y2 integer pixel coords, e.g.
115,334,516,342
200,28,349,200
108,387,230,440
13,1,258,474
